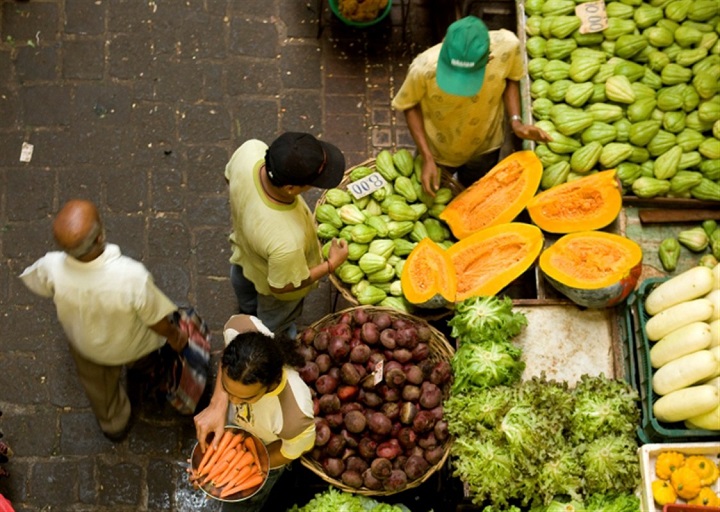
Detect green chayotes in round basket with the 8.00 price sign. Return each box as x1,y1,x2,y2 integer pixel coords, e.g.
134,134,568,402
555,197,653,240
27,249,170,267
315,149,462,312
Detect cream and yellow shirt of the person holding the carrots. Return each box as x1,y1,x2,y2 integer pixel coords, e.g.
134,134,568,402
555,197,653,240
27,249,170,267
223,315,315,459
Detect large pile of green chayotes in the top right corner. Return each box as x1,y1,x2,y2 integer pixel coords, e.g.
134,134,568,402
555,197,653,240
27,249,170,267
525,0,720,201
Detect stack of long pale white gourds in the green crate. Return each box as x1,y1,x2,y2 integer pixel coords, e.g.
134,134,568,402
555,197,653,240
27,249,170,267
644,265,720,430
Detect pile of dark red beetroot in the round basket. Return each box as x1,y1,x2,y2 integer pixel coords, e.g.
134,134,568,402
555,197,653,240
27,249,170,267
300,306,452,492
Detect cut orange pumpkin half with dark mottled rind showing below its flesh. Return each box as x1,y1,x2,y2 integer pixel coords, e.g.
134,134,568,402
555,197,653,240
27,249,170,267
540,231,642,308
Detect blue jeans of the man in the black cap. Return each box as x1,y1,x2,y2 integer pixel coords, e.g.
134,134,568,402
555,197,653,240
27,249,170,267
230,265,303,339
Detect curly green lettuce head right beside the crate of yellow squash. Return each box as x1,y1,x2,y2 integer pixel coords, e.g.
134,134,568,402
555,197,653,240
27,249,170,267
582,435,640,493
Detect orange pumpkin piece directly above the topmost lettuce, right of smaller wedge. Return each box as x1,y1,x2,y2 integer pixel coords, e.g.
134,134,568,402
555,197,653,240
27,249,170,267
447,222,543,302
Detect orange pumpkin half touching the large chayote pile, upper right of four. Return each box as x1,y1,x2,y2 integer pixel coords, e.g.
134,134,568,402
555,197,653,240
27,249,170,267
527,169,622,233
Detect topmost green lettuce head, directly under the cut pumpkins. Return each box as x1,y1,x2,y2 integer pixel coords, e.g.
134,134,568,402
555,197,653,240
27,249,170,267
448,295,527,343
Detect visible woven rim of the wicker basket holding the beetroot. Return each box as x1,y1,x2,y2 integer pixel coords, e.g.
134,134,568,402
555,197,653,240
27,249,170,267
300,306,455,496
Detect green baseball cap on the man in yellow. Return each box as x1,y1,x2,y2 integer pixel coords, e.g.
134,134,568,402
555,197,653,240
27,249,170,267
436,16,490,96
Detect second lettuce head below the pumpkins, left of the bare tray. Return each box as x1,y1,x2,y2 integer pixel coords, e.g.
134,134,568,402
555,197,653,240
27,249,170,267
451,341,525,393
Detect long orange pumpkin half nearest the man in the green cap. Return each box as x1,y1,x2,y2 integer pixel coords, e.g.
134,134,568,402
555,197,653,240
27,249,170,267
440,151,542,240
